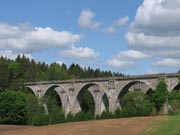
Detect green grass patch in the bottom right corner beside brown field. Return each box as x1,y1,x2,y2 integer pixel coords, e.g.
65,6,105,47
139,115,180,135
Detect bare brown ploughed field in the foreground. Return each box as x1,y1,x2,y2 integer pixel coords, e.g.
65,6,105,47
0,117,164,135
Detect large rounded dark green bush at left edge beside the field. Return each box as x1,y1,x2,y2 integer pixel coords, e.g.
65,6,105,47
0,90,27,124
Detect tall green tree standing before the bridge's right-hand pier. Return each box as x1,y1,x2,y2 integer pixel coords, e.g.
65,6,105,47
151,81,168,112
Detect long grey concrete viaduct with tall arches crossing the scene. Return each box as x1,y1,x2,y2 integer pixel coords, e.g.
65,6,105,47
24,73,180,115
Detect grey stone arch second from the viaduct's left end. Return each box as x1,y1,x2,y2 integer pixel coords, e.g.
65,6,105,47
42,84,70,114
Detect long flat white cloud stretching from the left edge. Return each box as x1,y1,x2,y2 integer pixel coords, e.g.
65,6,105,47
0,23,82,52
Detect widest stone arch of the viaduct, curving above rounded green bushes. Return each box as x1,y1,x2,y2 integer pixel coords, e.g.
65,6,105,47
116,80,152,107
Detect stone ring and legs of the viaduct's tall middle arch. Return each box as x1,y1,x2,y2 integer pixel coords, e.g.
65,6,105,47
73,83,100,114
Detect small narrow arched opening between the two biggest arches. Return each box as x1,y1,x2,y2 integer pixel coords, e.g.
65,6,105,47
101,93,109,113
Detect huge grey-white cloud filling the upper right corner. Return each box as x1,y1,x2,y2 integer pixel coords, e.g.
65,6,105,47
125,0,180,67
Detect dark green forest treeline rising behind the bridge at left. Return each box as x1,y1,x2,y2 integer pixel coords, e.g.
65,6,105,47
0,55,123,90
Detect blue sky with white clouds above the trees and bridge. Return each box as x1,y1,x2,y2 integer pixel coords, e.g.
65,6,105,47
0,0,180,74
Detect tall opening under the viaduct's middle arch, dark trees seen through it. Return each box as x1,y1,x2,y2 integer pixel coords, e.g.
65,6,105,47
74,83,99,116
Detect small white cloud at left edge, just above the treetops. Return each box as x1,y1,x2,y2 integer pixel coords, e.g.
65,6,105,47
0,50,33,60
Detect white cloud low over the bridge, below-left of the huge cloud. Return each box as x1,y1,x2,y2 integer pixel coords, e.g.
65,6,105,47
107,50,149,69
